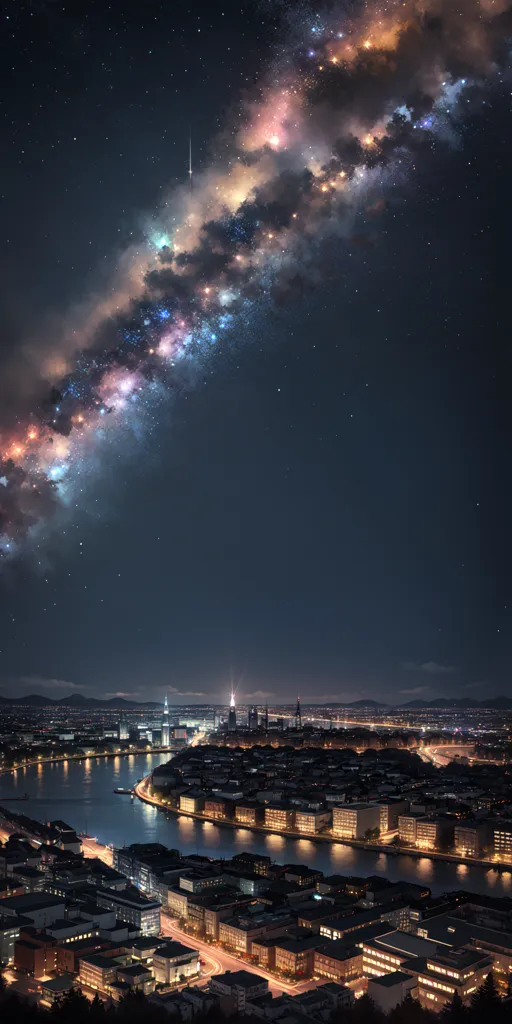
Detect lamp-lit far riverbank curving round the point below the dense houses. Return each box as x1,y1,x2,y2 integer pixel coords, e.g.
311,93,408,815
134,775,512,872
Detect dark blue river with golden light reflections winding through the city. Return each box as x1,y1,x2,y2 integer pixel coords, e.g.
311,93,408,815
0,754,512,896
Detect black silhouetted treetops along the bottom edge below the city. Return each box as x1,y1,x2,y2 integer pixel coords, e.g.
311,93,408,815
0,974,512,1024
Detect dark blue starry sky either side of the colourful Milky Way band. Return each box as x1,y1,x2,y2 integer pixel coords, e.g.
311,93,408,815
0,0,512,702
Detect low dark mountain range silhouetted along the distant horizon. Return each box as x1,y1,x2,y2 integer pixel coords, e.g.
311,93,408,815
0,693,512,711
